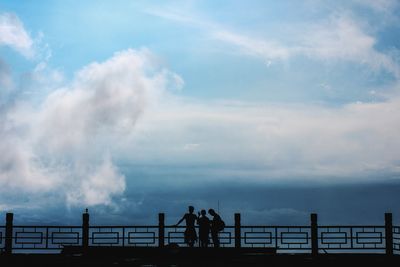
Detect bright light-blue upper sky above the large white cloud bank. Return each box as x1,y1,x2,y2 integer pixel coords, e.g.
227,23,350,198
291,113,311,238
2,1,399,104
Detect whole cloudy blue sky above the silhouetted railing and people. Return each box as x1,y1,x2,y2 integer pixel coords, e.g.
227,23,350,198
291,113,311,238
0,0,400,224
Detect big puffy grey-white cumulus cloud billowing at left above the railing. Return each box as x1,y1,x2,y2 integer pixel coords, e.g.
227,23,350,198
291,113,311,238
0,49,179,205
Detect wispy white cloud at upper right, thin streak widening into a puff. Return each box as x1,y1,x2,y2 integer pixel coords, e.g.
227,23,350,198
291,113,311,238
216,15,400,78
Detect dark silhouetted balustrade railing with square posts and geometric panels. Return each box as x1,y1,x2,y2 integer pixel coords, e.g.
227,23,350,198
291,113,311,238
0,214,400,254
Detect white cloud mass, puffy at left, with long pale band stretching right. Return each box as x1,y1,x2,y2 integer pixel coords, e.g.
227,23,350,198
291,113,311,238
0,45,400,211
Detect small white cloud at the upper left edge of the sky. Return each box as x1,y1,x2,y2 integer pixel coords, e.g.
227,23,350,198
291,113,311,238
0,13,34,58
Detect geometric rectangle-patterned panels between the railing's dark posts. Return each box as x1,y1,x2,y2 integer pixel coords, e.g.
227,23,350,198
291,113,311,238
0,226,400,253
